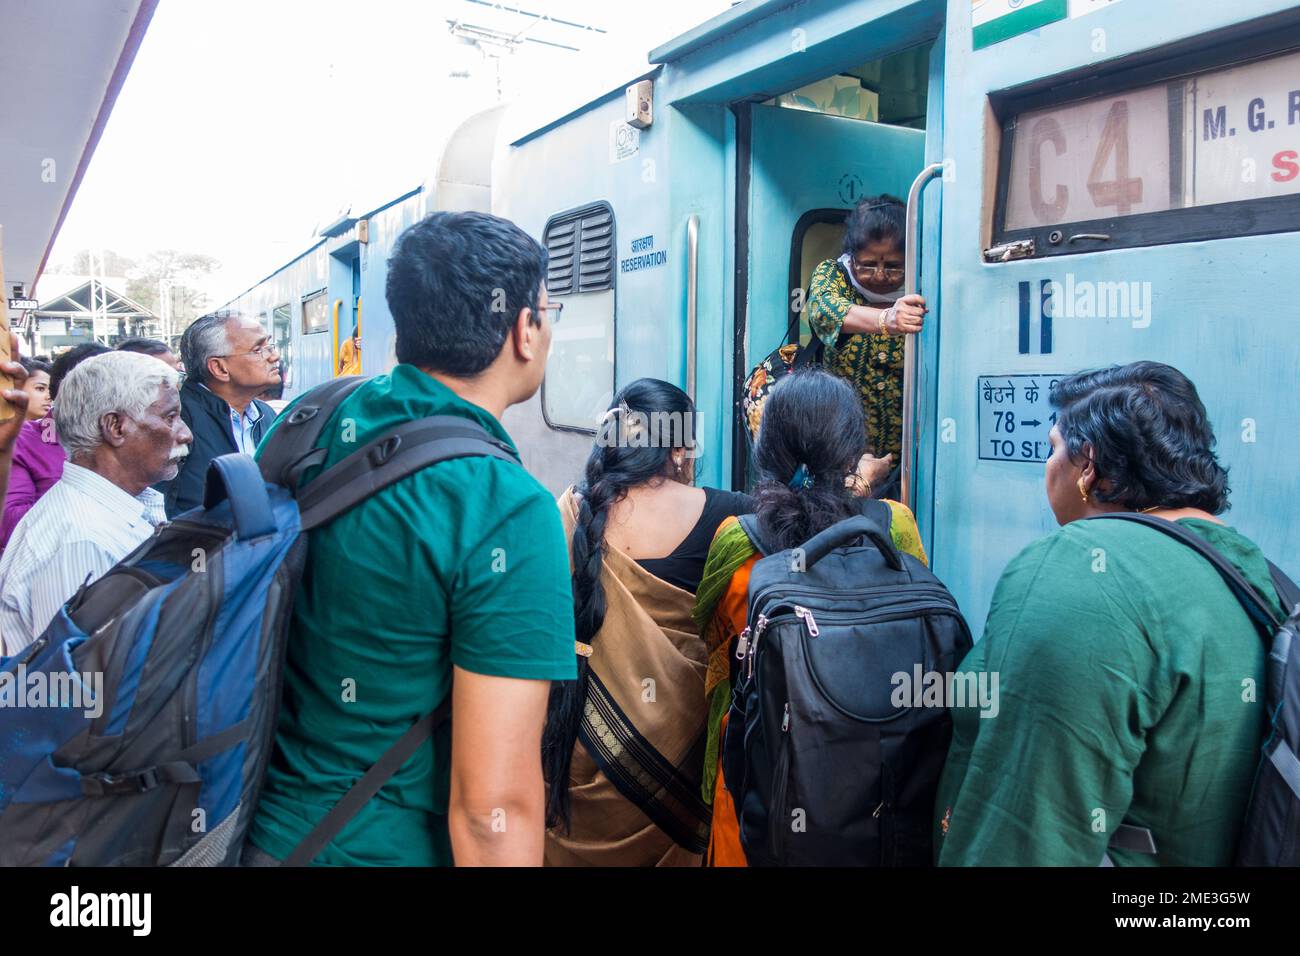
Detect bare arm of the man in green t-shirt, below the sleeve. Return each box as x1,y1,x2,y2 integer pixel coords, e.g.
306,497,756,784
449,667,551,866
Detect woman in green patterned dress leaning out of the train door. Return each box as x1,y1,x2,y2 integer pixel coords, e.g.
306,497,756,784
807,195,927,493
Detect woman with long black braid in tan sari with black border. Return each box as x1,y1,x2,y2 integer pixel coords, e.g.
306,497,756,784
542,378,753,866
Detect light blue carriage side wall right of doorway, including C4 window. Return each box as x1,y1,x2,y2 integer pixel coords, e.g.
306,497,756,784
946,0,1300,629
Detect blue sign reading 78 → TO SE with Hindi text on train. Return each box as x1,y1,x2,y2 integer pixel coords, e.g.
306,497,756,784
975,372,1063,463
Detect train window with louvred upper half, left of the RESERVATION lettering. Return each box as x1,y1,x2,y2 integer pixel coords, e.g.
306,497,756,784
542,203,615,432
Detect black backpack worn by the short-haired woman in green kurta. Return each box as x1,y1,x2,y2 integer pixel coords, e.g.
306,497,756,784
1093,511,1300,866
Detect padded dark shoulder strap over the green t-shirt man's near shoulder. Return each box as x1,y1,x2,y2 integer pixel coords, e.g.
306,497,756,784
298,415,519,531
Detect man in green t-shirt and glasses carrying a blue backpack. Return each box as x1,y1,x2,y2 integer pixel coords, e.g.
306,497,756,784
244,212,576,866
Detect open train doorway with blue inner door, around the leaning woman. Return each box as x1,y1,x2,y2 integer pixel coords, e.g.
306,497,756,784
732,43,941,528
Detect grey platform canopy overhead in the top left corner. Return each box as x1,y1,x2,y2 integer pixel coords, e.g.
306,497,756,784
0,0,157,295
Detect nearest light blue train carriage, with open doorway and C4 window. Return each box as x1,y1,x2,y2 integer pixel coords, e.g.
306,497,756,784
493,0,1300,632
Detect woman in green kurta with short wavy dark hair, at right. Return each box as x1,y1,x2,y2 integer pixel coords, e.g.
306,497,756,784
935,362,1281,866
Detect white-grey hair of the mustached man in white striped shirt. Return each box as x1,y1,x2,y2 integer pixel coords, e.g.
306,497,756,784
55,351,181,459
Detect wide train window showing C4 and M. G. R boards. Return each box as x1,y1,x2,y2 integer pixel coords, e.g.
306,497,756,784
988,41,1300,259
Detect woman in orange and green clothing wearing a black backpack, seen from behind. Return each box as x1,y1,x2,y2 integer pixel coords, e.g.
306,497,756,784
693,368,926,866
